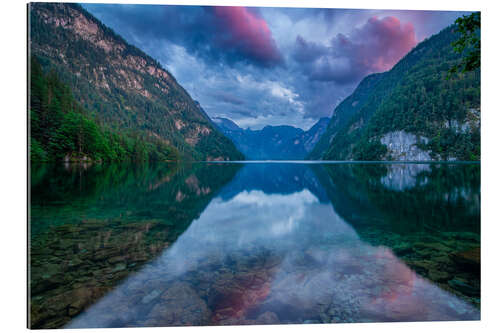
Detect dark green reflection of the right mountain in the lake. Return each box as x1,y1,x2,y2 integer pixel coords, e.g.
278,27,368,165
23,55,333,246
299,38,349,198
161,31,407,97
317,164,481,307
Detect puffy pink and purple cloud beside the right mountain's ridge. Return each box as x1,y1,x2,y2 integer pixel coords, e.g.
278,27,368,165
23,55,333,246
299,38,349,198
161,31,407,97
294,16,417,83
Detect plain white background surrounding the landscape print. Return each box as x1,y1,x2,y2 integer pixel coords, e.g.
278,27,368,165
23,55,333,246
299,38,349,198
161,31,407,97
0,0,500,333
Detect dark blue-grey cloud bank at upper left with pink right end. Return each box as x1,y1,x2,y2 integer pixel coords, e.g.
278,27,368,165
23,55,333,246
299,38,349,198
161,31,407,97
86,4,283,67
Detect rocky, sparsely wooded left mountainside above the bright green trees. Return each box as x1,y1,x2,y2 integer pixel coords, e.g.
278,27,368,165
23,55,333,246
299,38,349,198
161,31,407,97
29,3,243,160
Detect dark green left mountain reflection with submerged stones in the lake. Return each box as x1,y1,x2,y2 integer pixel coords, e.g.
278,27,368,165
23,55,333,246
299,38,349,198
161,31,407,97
29,164,239,328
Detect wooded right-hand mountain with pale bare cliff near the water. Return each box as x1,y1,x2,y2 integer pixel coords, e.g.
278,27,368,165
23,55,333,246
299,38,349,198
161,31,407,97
308,26,480,160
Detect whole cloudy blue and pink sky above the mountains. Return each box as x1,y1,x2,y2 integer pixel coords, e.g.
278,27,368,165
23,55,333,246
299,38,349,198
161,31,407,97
82,4,466,130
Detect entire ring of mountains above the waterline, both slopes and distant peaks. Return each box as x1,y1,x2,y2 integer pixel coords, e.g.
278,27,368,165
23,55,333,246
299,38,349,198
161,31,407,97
29,3,481,161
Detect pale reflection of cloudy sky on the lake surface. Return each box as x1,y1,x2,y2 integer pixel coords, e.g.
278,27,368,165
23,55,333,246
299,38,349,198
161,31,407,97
68,169,479,327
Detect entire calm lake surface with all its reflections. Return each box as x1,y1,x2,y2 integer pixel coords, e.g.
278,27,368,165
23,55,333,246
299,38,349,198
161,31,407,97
29,162,480,328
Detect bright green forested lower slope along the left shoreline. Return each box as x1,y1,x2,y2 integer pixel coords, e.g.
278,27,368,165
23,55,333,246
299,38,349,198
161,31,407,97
30,57,179,162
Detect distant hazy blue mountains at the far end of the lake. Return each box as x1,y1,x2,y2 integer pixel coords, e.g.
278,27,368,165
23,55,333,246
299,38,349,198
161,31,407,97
213,118,329,160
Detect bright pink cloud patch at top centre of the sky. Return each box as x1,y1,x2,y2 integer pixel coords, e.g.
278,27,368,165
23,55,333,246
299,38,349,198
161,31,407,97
214,7,283,65
